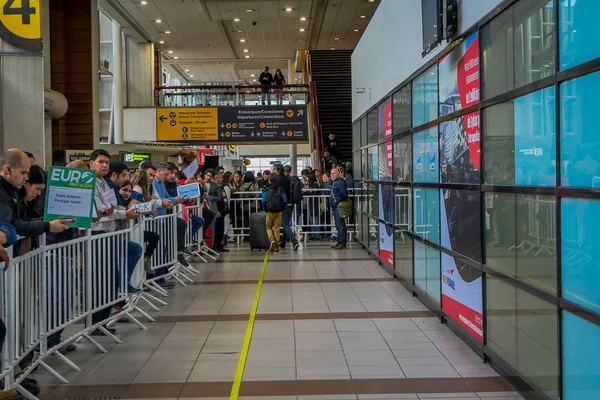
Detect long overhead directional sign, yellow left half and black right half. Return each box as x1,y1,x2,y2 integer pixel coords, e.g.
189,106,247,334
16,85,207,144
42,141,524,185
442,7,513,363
155,104,309,144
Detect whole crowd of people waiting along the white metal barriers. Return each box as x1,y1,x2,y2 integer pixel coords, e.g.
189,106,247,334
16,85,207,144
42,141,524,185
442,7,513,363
0,149,352,399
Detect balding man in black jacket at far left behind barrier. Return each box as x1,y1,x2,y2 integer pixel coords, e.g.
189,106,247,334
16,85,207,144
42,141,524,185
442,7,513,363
0,149,69,244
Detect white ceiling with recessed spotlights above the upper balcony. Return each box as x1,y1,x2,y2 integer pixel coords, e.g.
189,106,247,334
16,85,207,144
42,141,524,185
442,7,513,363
108,0,380,83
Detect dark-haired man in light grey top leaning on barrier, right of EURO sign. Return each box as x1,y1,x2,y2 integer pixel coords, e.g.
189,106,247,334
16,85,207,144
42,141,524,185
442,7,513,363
90,149,142,336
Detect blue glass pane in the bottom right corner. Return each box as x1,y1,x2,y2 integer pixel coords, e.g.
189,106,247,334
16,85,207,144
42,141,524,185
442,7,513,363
563,311,600,400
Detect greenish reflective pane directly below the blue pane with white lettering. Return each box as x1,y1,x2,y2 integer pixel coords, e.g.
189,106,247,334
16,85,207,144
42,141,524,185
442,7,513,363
485,193,564,293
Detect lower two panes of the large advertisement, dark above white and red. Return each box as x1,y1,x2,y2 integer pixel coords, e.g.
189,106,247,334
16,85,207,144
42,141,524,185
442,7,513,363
440,190,483,342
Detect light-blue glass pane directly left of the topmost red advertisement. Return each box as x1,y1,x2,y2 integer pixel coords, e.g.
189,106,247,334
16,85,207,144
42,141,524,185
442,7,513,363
412,64,438,127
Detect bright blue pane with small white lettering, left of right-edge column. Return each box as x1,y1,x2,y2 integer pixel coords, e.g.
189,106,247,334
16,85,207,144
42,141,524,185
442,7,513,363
514,87,556,186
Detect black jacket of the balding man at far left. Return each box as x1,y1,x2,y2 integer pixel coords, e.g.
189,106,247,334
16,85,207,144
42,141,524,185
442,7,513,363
0,176,50,237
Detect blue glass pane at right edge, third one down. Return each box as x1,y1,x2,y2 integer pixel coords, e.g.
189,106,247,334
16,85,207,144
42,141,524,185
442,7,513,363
561,199,600,312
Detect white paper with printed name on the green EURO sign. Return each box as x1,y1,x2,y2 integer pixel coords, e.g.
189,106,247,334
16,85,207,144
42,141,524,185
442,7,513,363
46,186,92,218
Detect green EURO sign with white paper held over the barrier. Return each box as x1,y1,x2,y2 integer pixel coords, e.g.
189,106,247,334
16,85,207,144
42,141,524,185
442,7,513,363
44,167,96,229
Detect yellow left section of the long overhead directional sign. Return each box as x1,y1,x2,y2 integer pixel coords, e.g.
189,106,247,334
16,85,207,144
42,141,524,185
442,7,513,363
156,107,219,141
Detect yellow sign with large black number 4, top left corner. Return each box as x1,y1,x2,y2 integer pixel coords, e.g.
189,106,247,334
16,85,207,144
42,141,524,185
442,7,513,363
0,0,42,39
